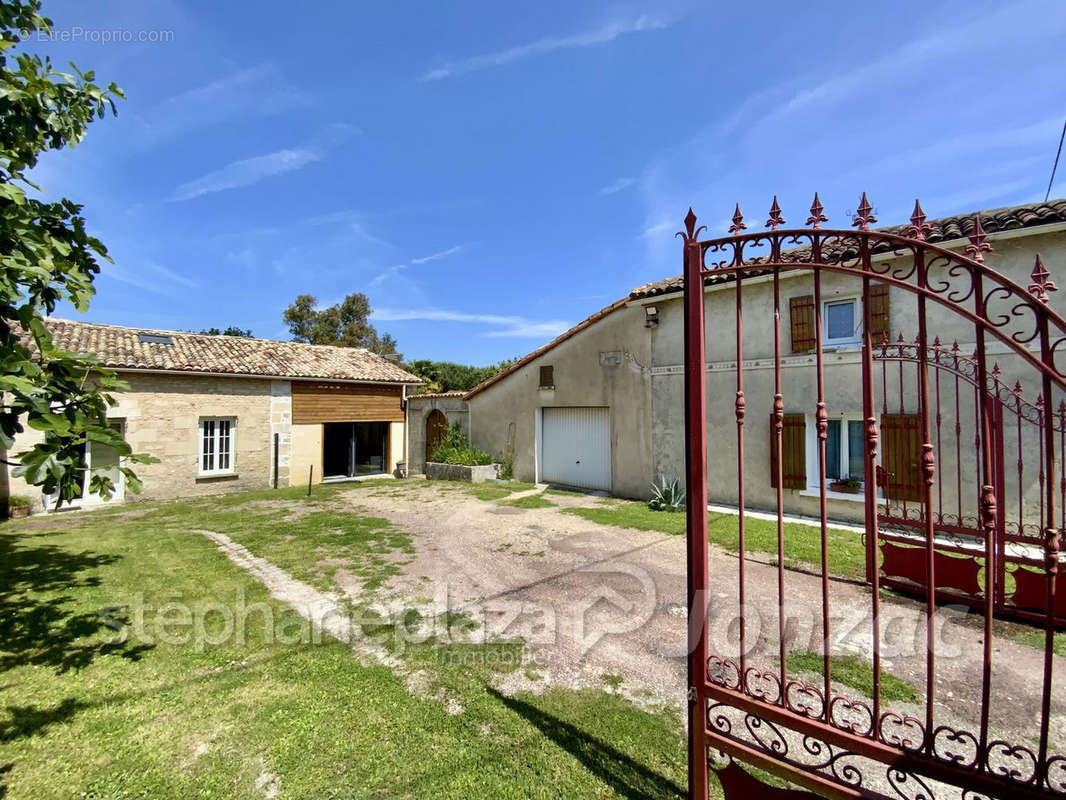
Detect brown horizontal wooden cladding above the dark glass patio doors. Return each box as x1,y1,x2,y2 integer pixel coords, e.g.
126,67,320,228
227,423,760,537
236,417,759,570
292,381,403,423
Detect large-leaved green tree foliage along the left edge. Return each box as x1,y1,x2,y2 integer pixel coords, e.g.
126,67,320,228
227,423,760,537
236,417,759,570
0,0,154,502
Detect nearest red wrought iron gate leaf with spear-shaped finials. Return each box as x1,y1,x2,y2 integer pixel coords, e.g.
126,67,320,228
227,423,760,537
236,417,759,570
679,194,1066,800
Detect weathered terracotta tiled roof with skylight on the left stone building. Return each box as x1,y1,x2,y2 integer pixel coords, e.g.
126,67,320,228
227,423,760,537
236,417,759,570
45,317,422,384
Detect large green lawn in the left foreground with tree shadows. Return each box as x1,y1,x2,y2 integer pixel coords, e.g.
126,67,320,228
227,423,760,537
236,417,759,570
0,484,699,800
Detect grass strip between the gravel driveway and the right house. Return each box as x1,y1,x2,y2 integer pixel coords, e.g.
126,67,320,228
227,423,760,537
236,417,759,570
563,500,866,580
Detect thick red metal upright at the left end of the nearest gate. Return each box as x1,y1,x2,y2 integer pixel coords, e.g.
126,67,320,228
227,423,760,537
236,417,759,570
682,208,708,800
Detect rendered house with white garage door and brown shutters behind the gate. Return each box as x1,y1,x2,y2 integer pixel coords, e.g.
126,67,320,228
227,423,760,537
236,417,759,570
428,199,1066,529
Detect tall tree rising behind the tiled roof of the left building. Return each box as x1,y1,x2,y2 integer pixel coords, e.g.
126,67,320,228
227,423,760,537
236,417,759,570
282,292,397,355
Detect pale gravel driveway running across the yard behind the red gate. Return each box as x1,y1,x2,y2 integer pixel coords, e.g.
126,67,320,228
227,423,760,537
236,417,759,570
330,480,1066,752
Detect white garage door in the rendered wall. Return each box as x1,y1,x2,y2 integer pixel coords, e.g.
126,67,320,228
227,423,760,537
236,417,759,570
540,409,611,491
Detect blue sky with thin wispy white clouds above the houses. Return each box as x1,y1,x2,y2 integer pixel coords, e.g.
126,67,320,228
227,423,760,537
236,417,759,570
25,0,1066,364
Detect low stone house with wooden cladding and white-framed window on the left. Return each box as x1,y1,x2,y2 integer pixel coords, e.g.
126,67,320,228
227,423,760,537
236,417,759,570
0,318,421,514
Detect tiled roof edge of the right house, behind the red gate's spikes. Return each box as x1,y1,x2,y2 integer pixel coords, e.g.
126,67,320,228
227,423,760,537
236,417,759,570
629,198,1066,300
